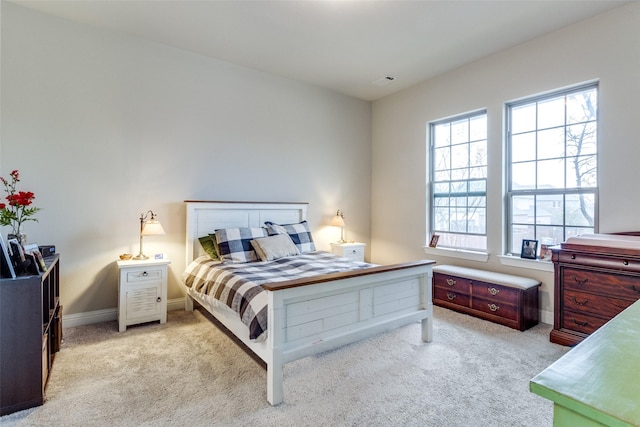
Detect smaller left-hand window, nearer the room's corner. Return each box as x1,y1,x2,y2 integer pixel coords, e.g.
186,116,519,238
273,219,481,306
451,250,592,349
429,111,487,251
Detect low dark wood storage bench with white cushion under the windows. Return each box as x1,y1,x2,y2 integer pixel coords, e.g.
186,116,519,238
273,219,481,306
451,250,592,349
433,265,540,331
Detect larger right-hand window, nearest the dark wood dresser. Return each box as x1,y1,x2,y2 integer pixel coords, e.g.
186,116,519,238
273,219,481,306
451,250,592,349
506,84,598,254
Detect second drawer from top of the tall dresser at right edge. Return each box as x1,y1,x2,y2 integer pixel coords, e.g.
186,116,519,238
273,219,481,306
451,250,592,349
562,267,640,301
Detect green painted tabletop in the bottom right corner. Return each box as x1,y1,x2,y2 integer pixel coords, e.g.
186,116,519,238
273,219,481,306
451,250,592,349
529,301,640,427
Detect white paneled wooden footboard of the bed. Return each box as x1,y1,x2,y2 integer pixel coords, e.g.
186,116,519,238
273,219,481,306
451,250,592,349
267,262,433,405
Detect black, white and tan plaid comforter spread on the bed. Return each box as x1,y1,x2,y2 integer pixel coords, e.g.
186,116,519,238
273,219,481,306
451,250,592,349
182,251,372,341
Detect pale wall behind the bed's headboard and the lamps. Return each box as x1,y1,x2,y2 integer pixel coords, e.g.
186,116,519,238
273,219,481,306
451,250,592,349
0,2,371,315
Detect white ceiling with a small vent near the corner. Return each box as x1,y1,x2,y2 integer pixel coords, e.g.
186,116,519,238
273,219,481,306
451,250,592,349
12,0,628,101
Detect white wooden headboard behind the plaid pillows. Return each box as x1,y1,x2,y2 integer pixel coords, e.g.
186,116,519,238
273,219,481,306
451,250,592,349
185,200,309,265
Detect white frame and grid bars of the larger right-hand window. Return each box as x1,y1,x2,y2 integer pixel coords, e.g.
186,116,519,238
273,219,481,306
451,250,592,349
504,81,600,256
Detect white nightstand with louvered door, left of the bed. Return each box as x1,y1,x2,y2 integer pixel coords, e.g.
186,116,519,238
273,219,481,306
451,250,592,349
118,259,171,332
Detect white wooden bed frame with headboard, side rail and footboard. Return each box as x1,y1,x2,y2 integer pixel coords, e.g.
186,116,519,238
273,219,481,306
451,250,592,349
185,201,434,405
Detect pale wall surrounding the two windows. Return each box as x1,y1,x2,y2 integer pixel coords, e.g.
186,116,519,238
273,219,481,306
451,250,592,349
371,2,640,321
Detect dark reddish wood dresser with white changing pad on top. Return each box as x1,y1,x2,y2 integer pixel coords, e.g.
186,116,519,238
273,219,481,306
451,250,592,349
550,234,640,345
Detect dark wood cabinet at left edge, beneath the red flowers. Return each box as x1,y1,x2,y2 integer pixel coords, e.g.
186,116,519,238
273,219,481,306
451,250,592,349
0,255,62,415
